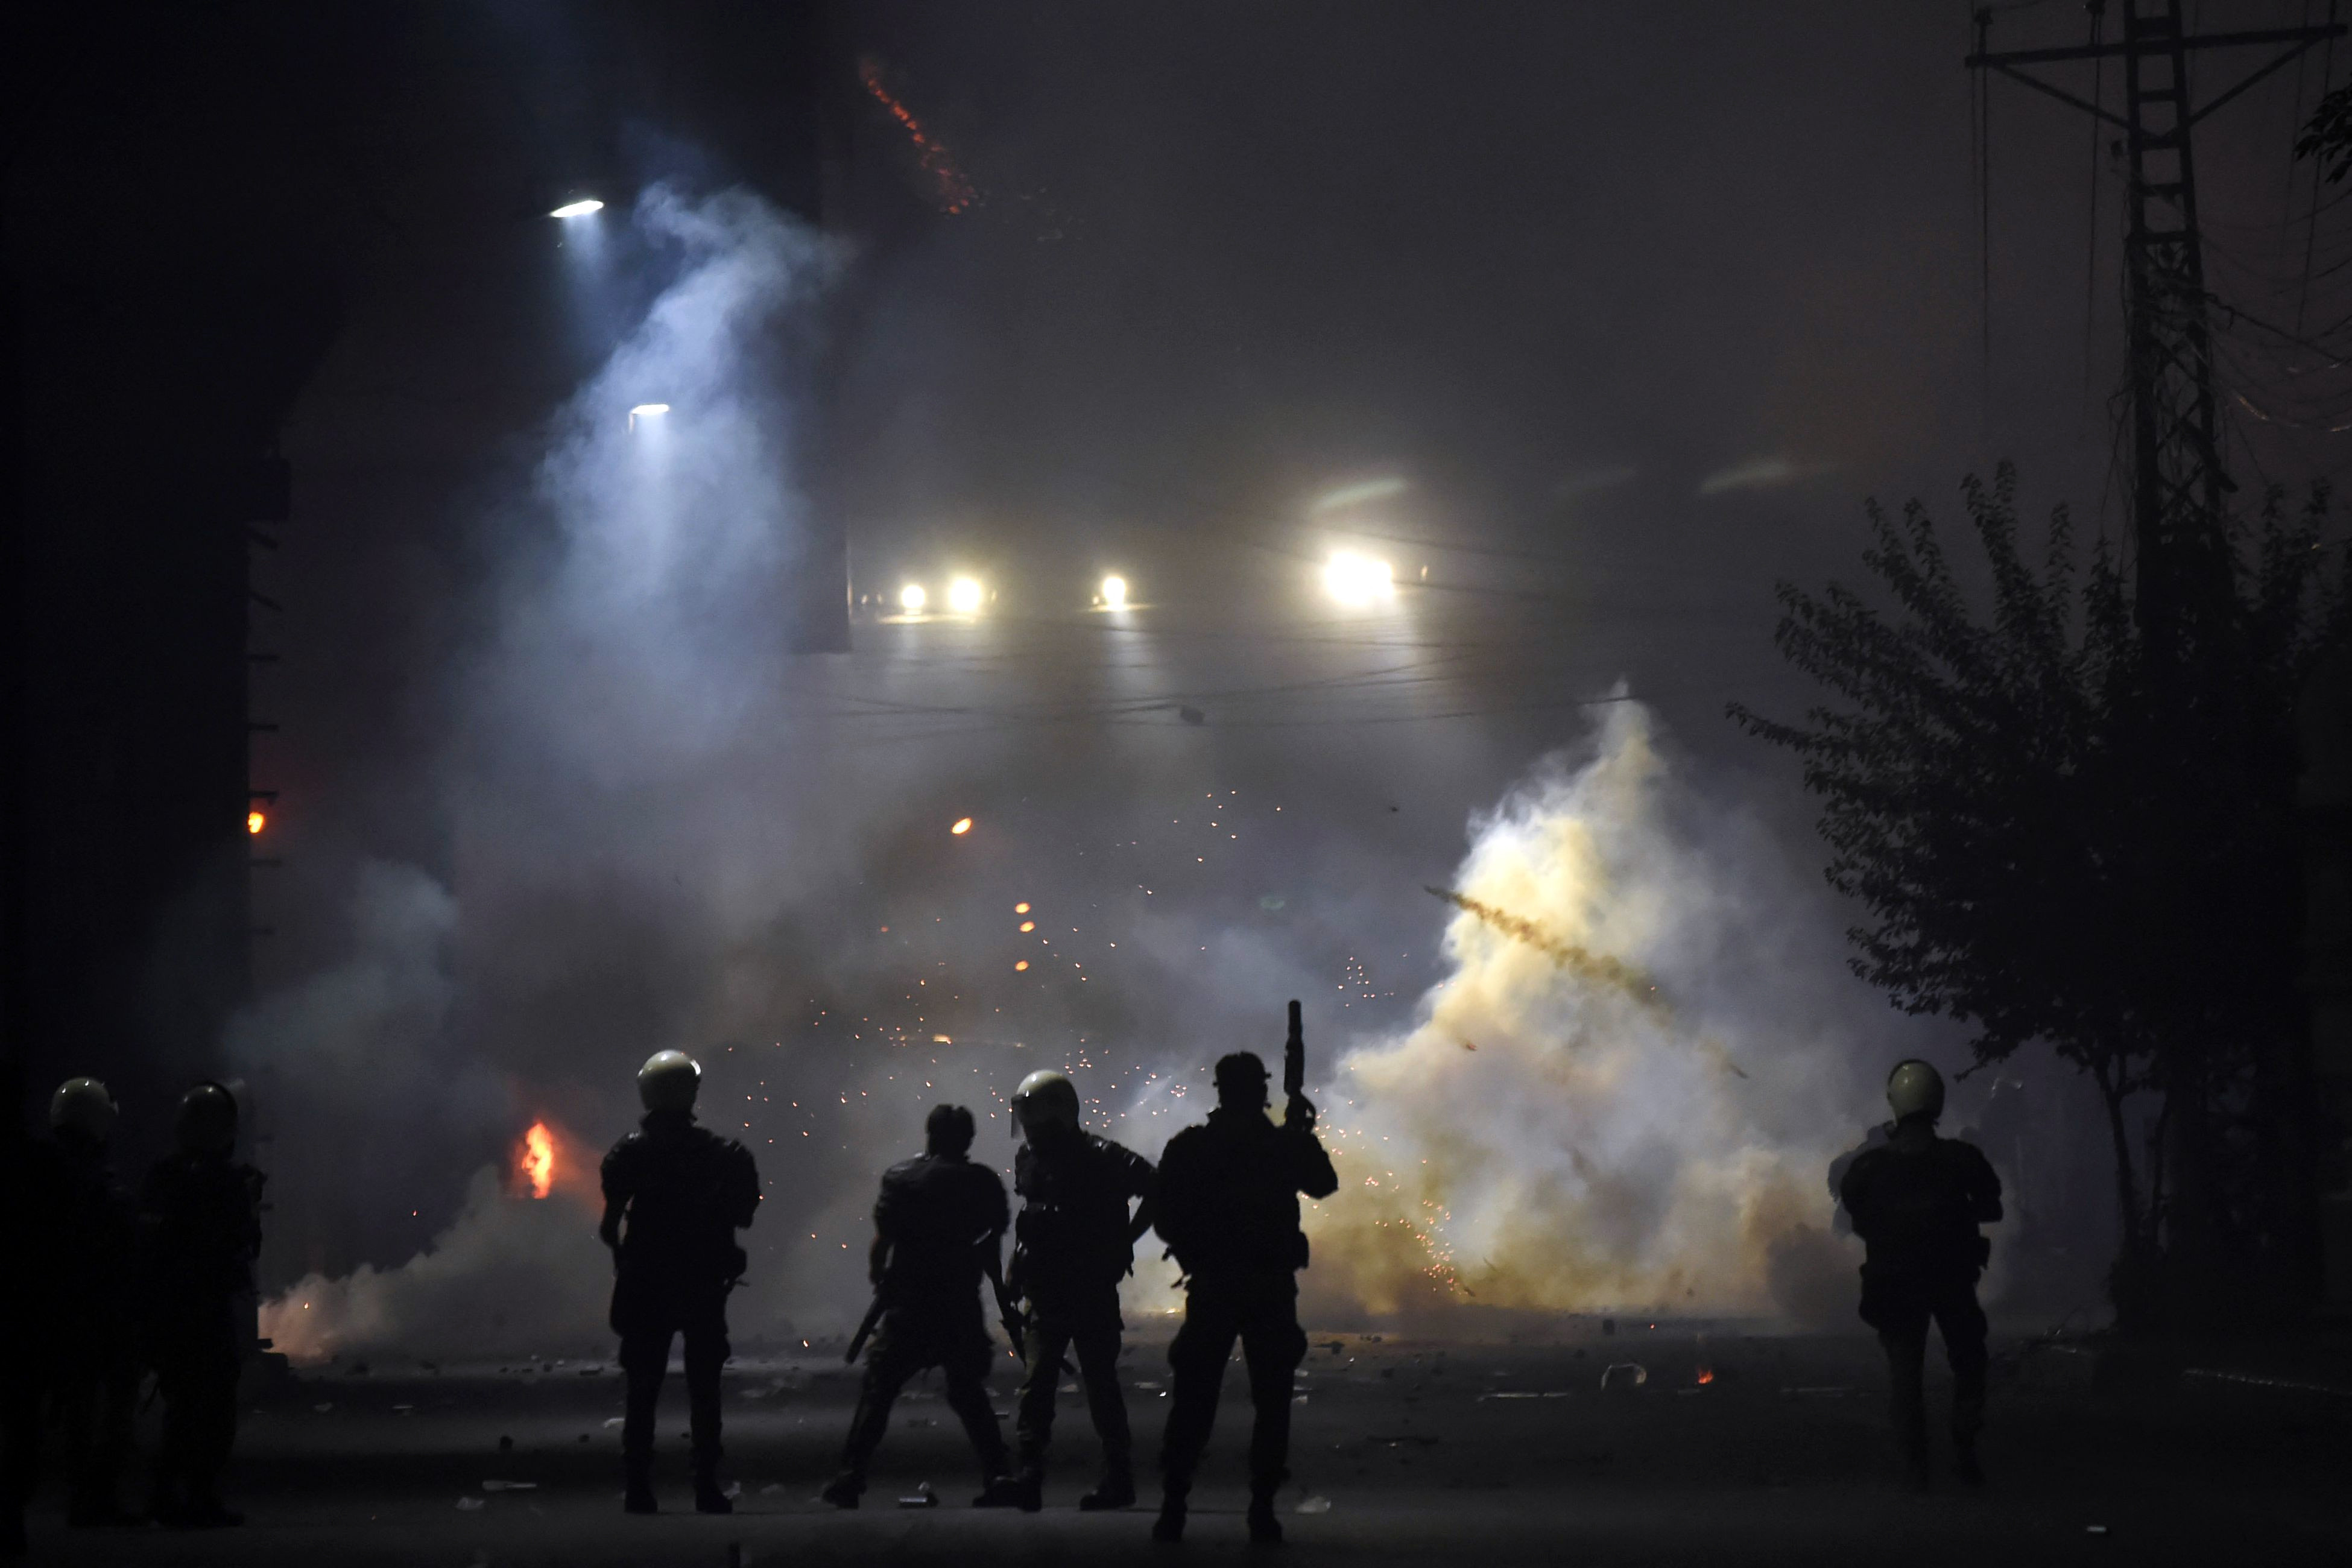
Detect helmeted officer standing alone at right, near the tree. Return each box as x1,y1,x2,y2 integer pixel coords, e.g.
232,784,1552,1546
1839,1060,2002,1486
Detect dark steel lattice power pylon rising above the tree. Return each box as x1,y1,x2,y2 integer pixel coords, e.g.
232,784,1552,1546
1966,0,2345,644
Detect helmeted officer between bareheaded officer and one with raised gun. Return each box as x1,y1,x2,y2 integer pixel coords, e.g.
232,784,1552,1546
1007,1067,1152,1511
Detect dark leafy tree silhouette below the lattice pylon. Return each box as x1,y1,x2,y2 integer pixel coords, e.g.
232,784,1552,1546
1731,463,2345,1326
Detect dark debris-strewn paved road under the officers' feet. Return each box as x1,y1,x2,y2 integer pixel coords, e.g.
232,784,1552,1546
9,1333,2352,1568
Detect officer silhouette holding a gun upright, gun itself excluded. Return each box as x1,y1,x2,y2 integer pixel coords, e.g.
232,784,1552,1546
1152,1051,1338,1542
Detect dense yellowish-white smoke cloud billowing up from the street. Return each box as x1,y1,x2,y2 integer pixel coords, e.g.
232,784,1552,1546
1307,703,1868,1319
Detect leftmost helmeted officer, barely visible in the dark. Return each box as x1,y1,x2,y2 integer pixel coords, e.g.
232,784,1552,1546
47,1079,139,1526
